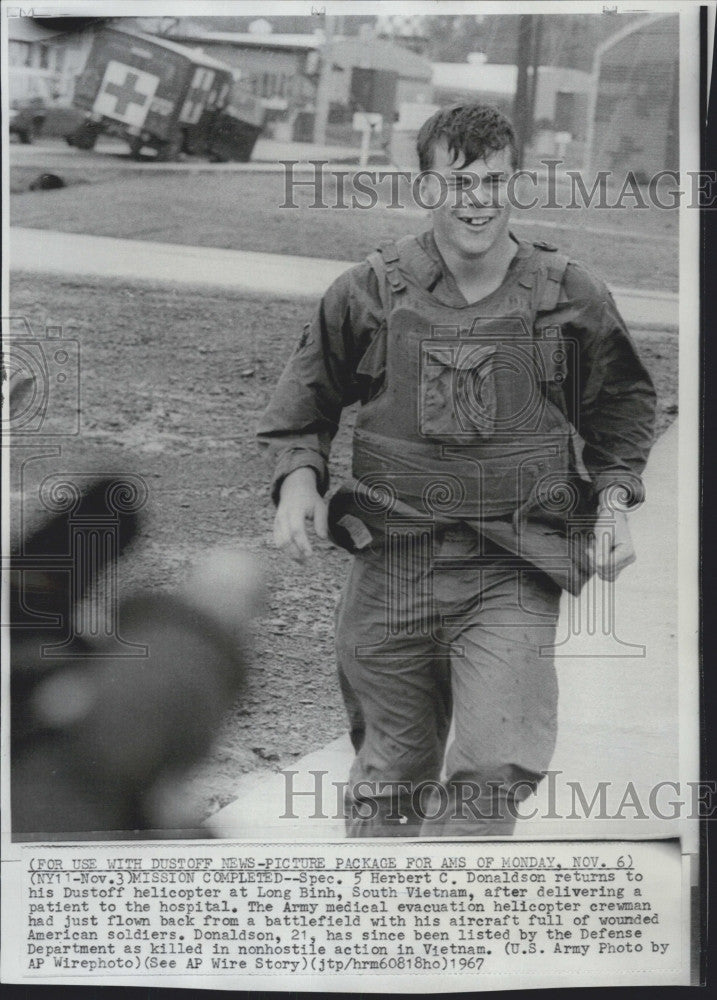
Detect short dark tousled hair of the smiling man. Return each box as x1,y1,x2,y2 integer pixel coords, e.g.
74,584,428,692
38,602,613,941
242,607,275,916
416,103,518,170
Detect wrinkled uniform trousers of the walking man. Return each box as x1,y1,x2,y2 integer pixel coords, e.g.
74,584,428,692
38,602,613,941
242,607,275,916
336,524,561,837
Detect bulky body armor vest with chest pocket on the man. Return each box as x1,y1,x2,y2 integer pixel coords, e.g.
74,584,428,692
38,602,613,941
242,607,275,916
353,237,571,520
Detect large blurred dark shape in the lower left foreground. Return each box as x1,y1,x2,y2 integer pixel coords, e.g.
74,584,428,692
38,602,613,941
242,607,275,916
10,479,262,840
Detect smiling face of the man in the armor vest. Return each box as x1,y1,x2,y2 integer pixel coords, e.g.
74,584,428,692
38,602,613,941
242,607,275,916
423,143,513,258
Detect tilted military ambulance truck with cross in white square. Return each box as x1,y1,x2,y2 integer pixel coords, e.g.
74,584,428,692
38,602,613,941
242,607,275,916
67,27,265,161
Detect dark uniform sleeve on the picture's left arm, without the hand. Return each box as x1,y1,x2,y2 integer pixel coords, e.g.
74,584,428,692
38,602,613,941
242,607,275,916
257,263,381,504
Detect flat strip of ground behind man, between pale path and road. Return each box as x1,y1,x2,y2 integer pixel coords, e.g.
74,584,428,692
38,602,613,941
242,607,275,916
11,164,679,291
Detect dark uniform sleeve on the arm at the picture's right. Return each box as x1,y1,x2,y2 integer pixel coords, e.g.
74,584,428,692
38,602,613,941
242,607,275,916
562,264,656,509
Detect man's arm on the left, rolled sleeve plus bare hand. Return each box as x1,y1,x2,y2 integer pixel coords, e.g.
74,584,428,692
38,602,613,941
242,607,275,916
258,264,381,562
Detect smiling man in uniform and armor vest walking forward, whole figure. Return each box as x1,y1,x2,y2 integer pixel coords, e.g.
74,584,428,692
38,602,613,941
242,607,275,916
259,104,655,837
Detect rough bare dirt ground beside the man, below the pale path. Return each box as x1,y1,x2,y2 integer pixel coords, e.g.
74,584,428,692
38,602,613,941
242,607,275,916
11,274,677,814
